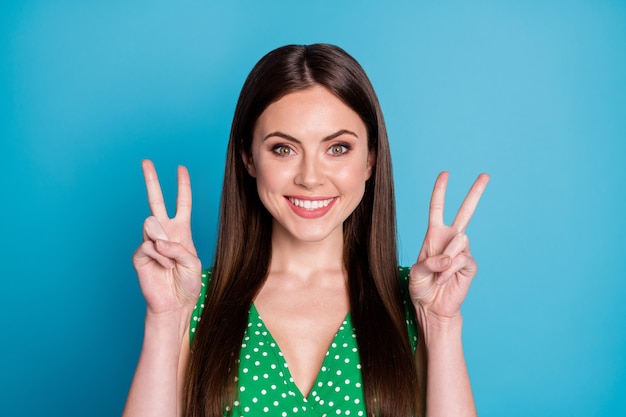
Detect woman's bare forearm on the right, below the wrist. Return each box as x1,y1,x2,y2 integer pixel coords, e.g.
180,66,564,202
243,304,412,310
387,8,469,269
416,316,476,417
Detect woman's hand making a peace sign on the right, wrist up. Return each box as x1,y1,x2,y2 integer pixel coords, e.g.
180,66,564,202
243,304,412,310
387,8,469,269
409,172,489,327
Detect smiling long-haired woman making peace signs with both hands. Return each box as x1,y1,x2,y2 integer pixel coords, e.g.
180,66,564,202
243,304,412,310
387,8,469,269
124,44,489,417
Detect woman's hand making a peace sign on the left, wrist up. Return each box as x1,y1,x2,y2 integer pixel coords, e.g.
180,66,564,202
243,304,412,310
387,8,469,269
133,160,202,315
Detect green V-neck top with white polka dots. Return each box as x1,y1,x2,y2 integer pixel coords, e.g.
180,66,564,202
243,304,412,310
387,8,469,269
190,268,417,417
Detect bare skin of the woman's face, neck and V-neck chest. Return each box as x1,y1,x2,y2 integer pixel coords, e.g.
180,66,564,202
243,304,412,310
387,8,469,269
243,87,374,395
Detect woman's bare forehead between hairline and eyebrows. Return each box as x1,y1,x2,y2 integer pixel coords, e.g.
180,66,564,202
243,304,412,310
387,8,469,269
254,86,366,137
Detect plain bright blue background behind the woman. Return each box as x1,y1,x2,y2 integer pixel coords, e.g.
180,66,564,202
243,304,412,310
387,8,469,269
0,0,626,416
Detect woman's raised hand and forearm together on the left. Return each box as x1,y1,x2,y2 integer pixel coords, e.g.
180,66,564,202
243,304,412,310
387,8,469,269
123,161,202,416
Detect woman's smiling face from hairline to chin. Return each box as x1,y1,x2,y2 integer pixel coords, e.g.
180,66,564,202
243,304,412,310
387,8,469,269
243,86,375,242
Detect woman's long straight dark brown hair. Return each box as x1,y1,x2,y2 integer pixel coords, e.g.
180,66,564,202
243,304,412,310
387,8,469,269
184,44,419,417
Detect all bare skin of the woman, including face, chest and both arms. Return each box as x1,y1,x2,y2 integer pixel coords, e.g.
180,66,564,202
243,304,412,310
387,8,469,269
124,87,489,416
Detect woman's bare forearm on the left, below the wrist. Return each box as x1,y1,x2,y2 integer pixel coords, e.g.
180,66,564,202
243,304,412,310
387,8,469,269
123,311,190,417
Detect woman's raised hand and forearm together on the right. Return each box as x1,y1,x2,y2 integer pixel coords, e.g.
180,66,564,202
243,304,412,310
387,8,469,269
409,172,489,417
